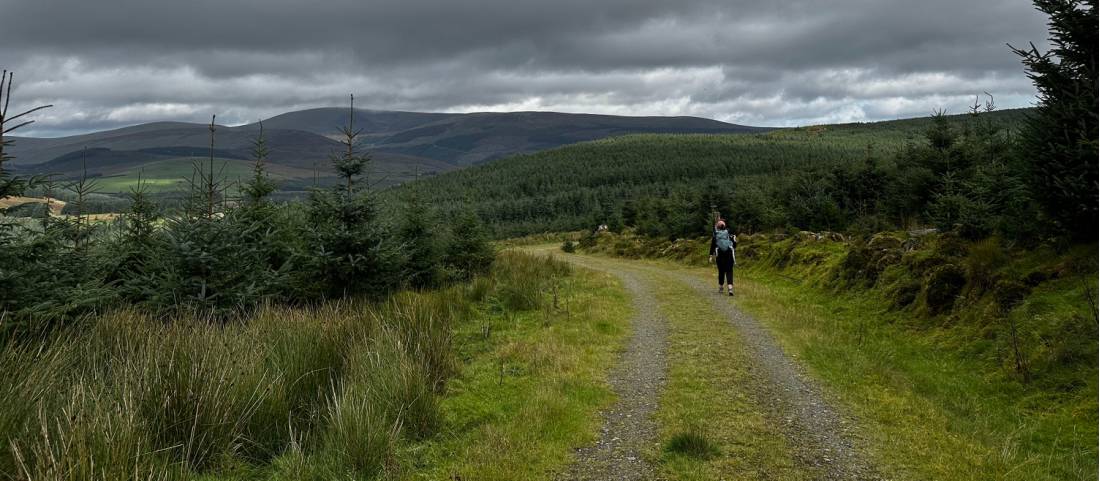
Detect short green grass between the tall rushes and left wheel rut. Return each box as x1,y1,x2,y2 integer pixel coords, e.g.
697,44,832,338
403,253,630,480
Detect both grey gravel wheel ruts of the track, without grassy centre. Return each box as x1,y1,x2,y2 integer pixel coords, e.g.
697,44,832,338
560,250,883,481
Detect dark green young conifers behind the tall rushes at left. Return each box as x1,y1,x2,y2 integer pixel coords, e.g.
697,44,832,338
0,90,494,329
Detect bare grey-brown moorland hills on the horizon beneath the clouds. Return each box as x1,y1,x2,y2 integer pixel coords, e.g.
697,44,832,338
10,108,768,190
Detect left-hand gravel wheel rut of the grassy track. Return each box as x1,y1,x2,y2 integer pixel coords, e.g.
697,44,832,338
559,256,668,480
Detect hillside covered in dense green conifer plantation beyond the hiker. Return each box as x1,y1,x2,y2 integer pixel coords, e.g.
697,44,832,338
386,109,1027,237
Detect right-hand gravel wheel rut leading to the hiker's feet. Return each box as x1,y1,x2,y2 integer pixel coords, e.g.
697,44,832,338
668,267,882,480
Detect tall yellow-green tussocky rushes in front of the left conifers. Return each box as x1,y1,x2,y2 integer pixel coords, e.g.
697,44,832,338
0,252,569,480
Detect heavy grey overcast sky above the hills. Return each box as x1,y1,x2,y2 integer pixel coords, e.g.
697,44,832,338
0,0,1047,135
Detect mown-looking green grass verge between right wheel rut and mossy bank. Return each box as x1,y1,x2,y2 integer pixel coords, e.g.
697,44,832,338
738,269,1097,481
